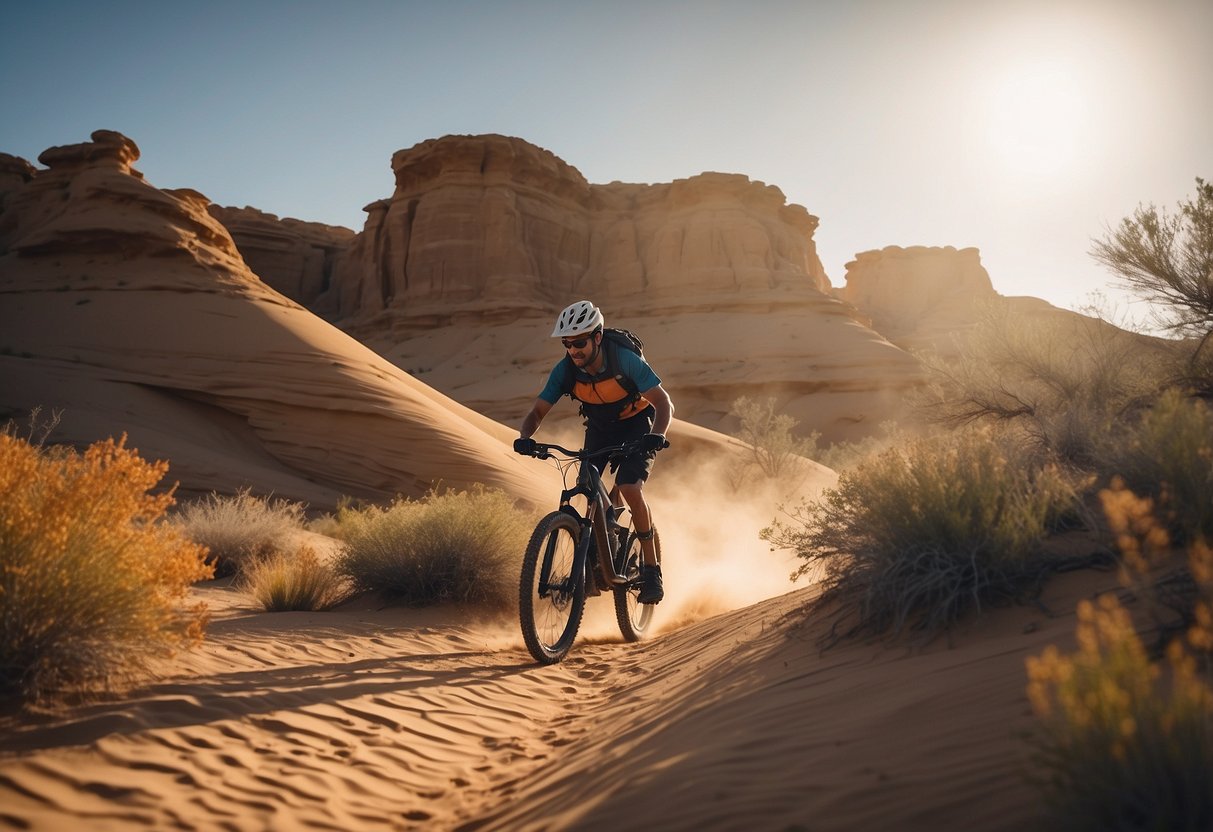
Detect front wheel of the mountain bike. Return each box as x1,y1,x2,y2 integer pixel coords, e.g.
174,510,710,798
518,512,586,665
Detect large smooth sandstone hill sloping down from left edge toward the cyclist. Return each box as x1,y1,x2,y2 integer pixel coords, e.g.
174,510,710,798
0,131,553,508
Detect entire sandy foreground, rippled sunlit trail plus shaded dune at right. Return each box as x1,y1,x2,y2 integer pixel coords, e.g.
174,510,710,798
0,553,1115,831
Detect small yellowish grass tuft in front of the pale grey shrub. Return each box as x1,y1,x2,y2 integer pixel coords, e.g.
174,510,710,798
240,546,349,612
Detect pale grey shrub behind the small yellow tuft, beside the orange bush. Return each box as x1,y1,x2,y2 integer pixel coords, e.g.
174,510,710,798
178,489,303,577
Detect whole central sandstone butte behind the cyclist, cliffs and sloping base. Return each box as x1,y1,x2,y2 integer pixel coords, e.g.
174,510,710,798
248,135,919,439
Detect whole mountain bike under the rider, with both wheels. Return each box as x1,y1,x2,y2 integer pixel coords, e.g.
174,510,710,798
518,441,661,665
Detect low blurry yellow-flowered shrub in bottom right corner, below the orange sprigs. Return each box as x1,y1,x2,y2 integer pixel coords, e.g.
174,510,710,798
1027,595,1213,832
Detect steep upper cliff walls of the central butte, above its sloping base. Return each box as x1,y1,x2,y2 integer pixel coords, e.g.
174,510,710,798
317,135,828,321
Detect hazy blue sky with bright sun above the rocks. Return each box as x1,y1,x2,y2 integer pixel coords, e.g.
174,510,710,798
0,0,1213,320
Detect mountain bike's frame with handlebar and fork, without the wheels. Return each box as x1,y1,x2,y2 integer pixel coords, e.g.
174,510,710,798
535,443,637,594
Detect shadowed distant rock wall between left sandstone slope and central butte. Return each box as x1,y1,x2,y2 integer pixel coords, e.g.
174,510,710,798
206,204,354,306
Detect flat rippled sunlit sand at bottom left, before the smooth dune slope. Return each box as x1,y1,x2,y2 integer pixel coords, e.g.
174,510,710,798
0,589,586,830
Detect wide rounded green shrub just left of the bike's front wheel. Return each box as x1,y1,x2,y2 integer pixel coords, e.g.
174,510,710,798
337,488,531,608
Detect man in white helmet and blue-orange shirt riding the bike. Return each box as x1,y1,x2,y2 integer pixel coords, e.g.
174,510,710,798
514,301,674,604
